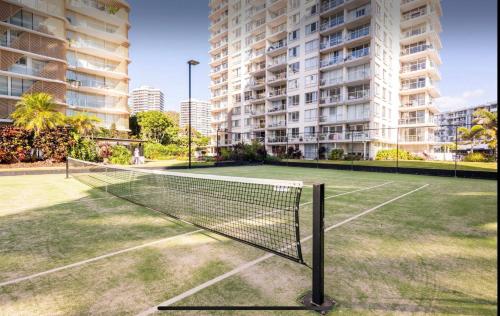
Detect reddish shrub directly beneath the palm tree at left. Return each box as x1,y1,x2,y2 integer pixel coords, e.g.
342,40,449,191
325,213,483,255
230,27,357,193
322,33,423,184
33,127,75,162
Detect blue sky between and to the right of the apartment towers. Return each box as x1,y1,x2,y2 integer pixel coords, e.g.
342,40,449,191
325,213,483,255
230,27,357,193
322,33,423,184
129,0,498,111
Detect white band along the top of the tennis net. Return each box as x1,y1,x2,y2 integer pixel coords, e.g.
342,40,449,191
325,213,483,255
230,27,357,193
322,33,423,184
68,158,304,188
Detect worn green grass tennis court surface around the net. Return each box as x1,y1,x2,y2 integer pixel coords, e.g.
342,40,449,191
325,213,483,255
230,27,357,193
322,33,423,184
0,166,497,315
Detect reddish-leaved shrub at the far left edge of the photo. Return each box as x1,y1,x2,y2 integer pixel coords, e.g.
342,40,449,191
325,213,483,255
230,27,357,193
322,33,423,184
0,126,32,163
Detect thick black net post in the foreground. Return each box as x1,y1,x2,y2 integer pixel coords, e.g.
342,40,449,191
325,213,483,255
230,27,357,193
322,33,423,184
311,183,325,306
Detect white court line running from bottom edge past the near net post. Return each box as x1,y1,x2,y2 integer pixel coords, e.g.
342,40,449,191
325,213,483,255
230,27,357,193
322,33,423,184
137,184,429,316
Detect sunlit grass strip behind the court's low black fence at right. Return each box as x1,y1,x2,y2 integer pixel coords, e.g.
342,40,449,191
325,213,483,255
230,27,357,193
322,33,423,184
283,159,497,172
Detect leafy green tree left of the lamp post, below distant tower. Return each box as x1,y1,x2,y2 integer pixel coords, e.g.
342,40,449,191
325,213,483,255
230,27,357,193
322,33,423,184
137,111,175,144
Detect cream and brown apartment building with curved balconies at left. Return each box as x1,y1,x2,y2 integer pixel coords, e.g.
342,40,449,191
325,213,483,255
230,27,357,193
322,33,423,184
0,0,130,130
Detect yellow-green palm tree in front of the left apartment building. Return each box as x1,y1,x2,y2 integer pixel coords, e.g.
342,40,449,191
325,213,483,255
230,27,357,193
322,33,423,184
11,93,65,138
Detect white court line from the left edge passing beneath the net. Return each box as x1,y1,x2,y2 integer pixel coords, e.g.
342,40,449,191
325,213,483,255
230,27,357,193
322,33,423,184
0,182,391,287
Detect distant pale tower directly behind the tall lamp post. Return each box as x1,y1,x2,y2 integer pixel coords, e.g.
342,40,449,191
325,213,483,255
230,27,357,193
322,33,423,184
179,99,211,136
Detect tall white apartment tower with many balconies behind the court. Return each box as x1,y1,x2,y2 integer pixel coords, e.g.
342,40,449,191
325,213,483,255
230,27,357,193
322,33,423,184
209,0,441,159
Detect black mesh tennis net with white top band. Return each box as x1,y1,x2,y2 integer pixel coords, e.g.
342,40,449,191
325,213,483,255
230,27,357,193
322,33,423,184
68,158,304,263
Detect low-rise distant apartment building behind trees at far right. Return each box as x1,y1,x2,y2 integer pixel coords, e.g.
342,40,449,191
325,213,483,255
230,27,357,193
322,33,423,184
437,102,498,147
